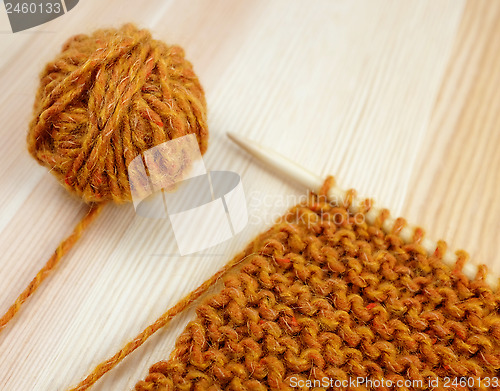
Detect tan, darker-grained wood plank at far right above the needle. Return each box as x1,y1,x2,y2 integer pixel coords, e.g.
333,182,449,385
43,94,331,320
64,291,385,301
402,1,500,274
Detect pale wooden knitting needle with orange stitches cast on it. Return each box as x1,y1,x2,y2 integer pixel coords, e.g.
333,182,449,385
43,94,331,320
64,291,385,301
227,132,498,289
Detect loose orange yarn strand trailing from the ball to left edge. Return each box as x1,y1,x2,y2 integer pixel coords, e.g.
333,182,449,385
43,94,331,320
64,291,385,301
0,203,104,332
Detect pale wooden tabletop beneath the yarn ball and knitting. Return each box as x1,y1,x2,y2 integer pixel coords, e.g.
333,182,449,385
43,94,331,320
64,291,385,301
0,0,500,391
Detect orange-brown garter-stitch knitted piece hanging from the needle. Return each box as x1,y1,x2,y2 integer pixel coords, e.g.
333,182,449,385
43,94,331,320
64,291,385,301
135,191,500,391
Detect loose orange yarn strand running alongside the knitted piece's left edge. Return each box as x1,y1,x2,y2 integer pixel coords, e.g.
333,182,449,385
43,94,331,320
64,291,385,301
68,251,252,391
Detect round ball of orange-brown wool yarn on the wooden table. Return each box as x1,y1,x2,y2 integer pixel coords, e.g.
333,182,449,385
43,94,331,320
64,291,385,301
27,25,208,202
